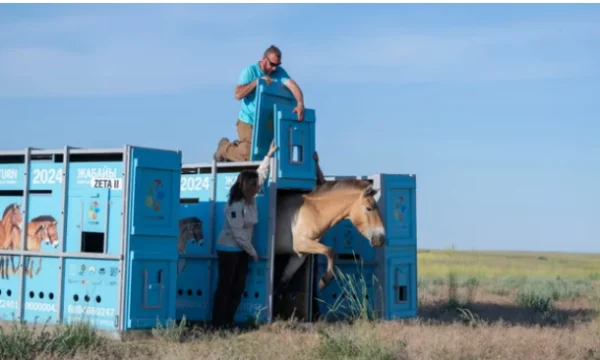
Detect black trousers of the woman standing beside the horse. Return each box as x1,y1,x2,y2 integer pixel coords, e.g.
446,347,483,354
212,251,249,328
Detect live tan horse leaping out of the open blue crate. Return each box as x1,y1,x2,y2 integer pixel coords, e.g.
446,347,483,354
275,179,385,292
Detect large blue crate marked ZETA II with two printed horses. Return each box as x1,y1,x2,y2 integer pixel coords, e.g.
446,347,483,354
0,146,181,334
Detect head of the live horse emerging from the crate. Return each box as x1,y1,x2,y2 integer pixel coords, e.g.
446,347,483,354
348,184,385,247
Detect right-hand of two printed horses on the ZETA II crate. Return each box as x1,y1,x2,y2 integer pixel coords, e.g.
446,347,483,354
19,215,58,278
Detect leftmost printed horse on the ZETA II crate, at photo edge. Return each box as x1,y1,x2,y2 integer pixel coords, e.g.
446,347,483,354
0,203,24,279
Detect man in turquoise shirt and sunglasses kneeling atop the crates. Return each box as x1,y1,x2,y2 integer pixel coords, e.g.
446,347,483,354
214,45,304,161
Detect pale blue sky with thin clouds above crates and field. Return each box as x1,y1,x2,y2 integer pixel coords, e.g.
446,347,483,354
0,4,600,252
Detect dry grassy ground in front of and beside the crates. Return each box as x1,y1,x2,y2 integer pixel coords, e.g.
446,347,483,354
0,252,600,360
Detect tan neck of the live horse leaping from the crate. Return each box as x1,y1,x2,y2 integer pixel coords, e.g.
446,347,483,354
305,189,360,234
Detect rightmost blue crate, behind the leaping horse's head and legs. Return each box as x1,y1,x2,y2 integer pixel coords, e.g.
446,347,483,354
314,174,418,319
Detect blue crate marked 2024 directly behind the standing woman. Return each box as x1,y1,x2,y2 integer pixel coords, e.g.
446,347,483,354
176,162,271,322
